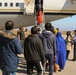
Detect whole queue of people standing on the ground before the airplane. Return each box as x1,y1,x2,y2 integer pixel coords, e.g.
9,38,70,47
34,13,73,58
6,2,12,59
0,20,76,75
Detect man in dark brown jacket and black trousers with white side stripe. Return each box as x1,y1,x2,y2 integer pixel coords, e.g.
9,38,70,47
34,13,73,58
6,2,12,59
24,27,45,75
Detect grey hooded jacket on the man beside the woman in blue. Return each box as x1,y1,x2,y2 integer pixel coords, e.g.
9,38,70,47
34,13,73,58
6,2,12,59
39,30,56,55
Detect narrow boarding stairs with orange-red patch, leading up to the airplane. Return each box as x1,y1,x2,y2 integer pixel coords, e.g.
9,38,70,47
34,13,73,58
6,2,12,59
35,0,45,30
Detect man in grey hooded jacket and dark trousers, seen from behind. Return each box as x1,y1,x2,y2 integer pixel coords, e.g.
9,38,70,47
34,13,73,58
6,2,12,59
39,23,56,75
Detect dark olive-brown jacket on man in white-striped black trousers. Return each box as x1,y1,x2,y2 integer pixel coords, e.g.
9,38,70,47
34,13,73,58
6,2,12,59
24,35,45,62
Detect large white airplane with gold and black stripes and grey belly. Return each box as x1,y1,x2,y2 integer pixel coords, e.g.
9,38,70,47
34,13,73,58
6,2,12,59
0,0,76,29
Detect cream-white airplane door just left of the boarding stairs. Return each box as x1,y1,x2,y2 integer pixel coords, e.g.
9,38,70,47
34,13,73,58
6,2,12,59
24,0,35,15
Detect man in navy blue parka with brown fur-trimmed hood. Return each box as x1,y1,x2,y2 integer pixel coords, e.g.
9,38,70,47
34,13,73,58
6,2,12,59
0,21,22,75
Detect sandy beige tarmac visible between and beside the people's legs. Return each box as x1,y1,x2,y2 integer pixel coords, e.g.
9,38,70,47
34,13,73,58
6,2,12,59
0,50,76,75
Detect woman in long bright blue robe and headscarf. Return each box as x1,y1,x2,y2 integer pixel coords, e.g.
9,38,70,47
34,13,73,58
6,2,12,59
56,32,66,71
